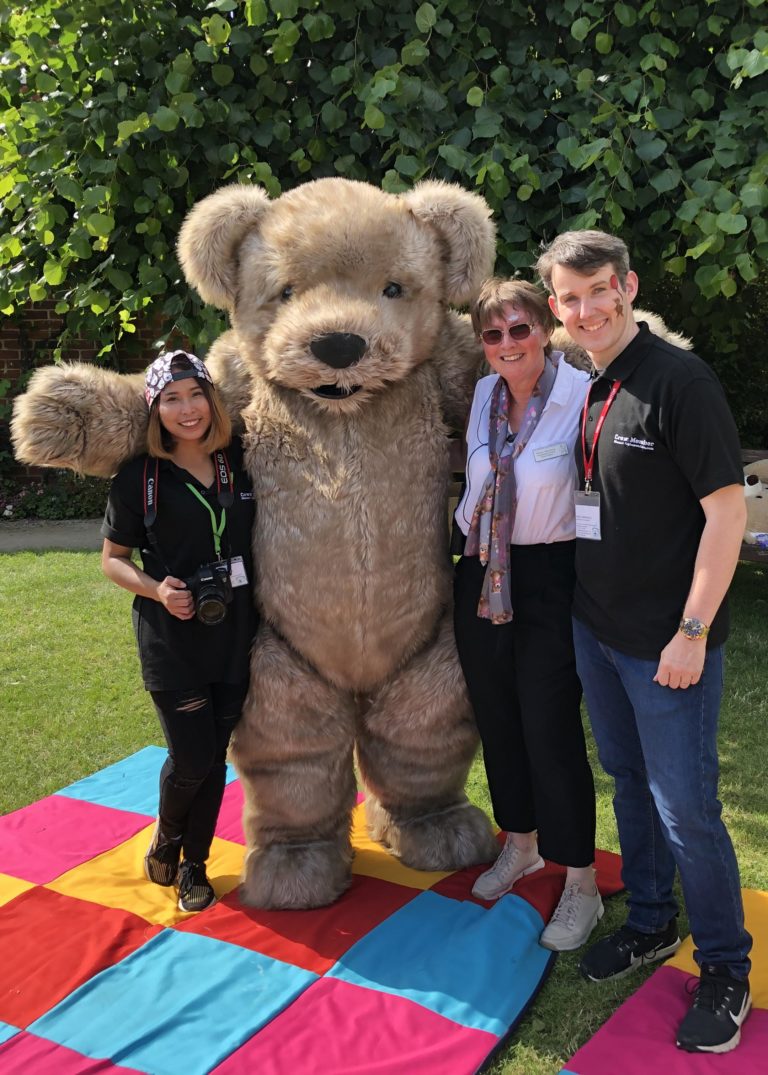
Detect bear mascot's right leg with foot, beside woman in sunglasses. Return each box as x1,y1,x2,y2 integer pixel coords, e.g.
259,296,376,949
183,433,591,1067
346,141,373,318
357,616,498,870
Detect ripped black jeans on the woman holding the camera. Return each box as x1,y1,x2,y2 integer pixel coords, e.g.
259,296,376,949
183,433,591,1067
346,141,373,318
151,682,248,862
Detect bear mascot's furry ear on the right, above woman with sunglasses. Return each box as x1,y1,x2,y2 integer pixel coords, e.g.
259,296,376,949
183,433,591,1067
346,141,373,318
401,181,496,305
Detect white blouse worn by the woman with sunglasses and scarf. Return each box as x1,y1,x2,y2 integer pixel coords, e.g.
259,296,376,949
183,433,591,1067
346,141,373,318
455,358,589,545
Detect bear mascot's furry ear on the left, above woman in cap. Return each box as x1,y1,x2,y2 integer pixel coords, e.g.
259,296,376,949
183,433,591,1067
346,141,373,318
179,184,270,310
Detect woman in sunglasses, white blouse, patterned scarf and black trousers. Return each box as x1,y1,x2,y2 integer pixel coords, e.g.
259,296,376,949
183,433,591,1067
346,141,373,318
455,280,602,951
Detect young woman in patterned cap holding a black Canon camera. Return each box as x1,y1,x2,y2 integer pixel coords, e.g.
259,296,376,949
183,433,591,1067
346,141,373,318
101,350,256,912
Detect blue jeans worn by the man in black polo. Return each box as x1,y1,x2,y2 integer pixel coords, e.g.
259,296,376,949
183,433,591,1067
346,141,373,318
573,619,752,978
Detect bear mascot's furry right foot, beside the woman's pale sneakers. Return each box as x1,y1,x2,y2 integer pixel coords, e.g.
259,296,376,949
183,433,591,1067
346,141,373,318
366,800,498,870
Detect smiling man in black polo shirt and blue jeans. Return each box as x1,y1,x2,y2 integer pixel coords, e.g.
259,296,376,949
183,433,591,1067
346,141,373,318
537,231,752,1052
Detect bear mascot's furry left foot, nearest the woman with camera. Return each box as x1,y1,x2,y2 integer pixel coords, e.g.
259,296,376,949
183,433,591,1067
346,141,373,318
240,841,352,911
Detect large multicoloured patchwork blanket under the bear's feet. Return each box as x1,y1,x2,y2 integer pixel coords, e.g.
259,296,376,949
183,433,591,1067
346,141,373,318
0,747,621,1075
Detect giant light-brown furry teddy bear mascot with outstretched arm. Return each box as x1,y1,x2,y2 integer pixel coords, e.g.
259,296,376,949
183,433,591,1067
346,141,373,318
13,178,498,907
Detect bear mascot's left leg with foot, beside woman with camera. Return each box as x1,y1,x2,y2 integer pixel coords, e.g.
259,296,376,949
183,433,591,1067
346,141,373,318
231,626,356,908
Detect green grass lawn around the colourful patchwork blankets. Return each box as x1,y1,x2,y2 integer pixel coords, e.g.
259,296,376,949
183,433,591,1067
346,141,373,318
0,553,768,1075
